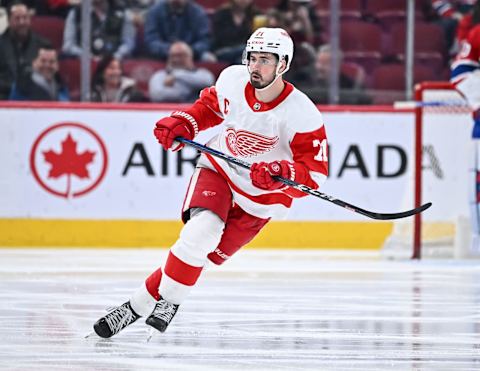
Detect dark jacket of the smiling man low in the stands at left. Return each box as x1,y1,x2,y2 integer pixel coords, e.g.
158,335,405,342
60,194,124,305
9,70,70,102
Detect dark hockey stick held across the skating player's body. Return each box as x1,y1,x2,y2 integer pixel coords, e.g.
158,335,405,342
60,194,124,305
175,137,432,220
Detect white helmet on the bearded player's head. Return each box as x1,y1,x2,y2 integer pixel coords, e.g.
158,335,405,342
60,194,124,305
243,27,293,75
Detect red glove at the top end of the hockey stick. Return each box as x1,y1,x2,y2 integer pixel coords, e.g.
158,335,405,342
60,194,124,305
153,112,198,151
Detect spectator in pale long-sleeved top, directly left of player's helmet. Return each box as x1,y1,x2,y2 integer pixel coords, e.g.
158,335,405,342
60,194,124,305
148,41,215,103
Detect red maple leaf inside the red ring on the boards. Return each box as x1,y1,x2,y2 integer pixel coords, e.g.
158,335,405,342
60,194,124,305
43,133,96,195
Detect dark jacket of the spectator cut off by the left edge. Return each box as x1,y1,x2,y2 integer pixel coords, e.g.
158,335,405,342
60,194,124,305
0,29,50,99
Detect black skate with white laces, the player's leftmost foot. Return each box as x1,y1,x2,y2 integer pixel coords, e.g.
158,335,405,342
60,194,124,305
93,301,140,338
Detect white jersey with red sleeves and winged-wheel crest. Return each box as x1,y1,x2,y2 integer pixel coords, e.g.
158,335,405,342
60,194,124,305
178,66,328,218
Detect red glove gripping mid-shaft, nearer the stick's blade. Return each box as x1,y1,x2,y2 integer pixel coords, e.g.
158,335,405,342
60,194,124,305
250,160,292,191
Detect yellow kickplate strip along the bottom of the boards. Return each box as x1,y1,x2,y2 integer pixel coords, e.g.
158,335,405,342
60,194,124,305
0,219,392,249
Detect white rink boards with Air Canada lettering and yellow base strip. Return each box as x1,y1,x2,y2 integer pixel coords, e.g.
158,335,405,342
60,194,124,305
0,103,470,248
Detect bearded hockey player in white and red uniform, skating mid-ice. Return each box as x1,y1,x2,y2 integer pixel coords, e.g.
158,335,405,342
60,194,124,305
94,28,328,338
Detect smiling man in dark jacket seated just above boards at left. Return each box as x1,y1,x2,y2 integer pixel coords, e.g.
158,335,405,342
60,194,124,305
10,48,70,102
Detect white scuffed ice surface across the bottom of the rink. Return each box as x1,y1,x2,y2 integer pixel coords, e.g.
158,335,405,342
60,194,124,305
0,250,480,371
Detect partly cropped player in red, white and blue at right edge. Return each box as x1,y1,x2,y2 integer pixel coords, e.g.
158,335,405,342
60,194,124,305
451,24,480,255
